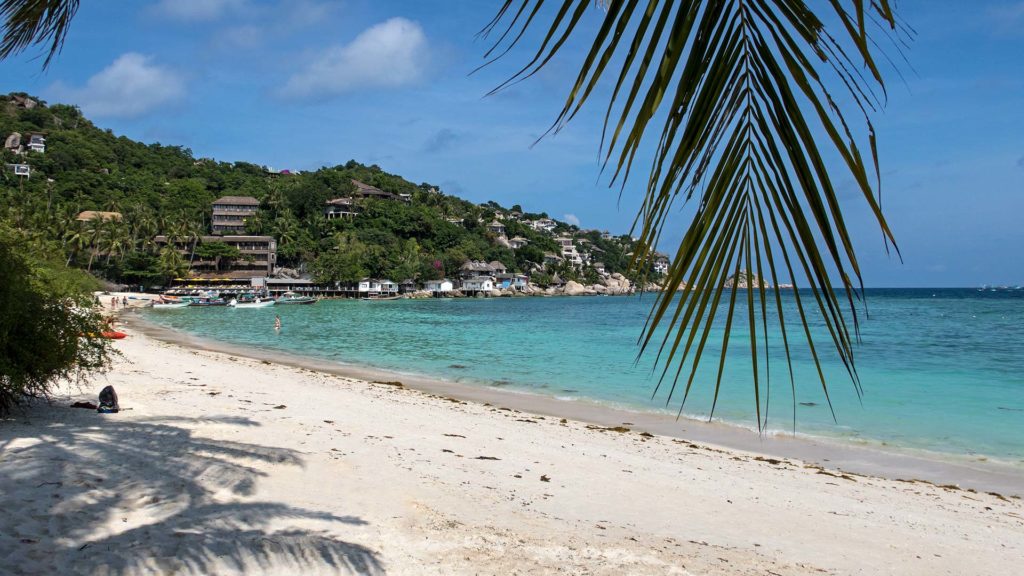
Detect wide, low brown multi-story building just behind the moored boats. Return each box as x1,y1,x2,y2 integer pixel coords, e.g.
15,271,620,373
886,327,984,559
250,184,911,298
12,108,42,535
154,236,278,278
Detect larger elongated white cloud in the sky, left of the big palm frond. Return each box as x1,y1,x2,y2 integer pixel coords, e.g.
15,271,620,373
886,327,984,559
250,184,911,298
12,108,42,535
281,17,429,97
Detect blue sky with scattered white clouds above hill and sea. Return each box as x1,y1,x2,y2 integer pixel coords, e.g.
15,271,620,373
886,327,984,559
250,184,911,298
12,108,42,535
0,0,1024,286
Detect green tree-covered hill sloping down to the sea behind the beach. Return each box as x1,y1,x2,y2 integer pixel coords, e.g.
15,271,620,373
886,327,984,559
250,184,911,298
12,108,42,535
0,93,651,284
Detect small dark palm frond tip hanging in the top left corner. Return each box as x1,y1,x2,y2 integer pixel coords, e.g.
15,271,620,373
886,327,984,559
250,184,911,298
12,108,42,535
0,0,79,69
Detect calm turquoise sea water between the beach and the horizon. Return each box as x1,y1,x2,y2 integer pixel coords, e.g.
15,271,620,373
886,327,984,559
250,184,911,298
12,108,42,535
147,289,1024,464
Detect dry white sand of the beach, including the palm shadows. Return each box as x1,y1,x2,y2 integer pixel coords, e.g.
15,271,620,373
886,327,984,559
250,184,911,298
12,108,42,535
0,303,1024,575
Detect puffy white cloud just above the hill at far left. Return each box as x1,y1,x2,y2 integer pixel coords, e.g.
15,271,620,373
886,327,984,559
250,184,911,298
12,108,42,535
49,52,185,118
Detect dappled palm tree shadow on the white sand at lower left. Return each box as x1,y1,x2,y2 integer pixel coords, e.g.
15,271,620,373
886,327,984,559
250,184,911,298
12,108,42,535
0,407,384,574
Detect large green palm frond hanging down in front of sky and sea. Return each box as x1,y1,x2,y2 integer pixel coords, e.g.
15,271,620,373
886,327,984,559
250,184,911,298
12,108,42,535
481,0,910,427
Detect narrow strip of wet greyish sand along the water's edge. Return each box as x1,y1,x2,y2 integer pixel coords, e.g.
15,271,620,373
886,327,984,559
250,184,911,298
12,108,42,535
125,311,1024,497
